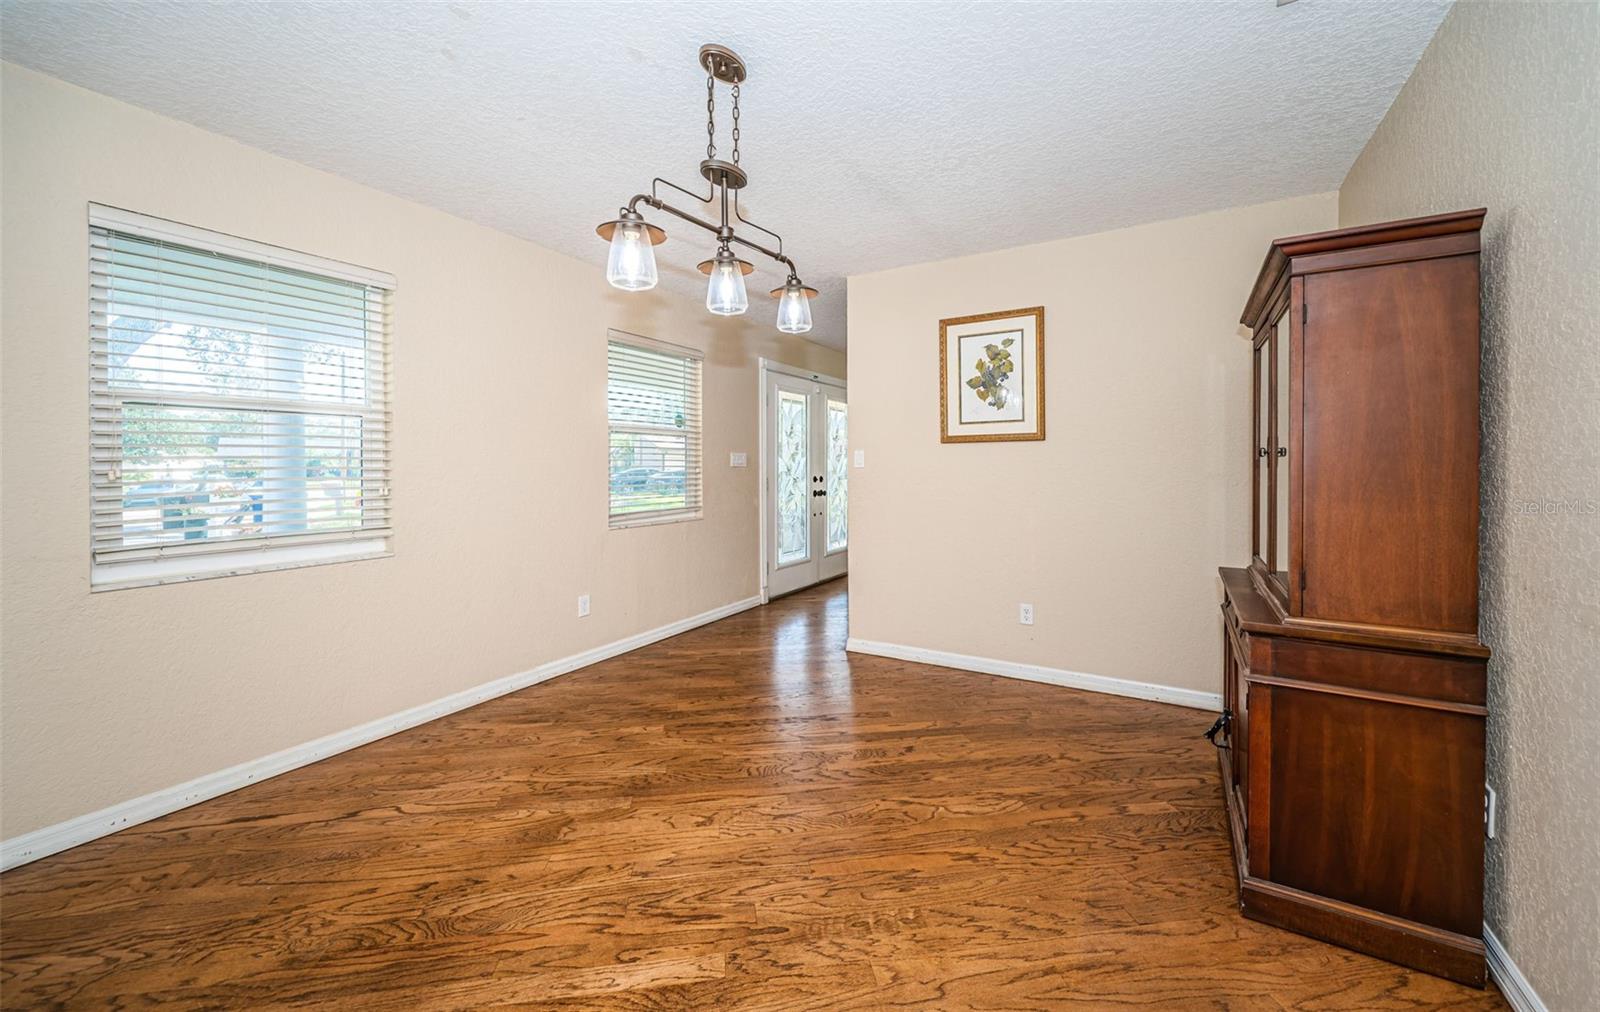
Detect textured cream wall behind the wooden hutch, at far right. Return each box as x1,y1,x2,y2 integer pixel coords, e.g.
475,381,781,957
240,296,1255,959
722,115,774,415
1339,2,1600,1009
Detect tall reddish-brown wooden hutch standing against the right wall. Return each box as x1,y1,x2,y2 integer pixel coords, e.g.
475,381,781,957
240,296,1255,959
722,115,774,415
1214,210,1490,986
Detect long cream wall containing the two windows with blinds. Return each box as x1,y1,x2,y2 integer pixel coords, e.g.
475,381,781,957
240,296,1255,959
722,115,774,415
0,66,845,839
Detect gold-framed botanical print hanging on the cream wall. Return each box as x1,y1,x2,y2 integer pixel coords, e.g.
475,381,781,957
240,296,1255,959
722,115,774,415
939,306,1045,442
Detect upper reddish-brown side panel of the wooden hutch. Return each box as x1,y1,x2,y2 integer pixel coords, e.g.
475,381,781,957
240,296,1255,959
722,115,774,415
1299,256,1478,633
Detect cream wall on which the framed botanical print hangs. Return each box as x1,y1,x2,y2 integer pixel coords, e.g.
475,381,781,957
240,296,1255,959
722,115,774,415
848,194,1336,694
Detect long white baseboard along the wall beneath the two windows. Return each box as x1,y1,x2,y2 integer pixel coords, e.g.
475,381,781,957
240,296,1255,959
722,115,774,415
0,596,762,871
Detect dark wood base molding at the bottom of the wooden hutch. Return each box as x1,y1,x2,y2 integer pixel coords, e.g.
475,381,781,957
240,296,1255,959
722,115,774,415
1218,751,1488,988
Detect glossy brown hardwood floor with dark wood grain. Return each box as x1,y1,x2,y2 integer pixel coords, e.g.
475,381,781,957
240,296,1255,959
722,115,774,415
0,581,1504,1009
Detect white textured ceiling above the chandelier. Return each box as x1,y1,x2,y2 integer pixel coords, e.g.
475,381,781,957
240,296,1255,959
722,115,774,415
0,0,1448,347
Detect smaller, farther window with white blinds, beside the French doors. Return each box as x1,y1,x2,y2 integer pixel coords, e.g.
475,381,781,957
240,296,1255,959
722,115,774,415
606,331,701,527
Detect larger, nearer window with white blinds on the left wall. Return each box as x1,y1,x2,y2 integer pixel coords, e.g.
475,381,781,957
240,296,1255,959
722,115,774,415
90,205,394,588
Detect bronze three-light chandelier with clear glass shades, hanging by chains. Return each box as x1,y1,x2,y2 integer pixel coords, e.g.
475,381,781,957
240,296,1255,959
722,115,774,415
595,45,816,333
